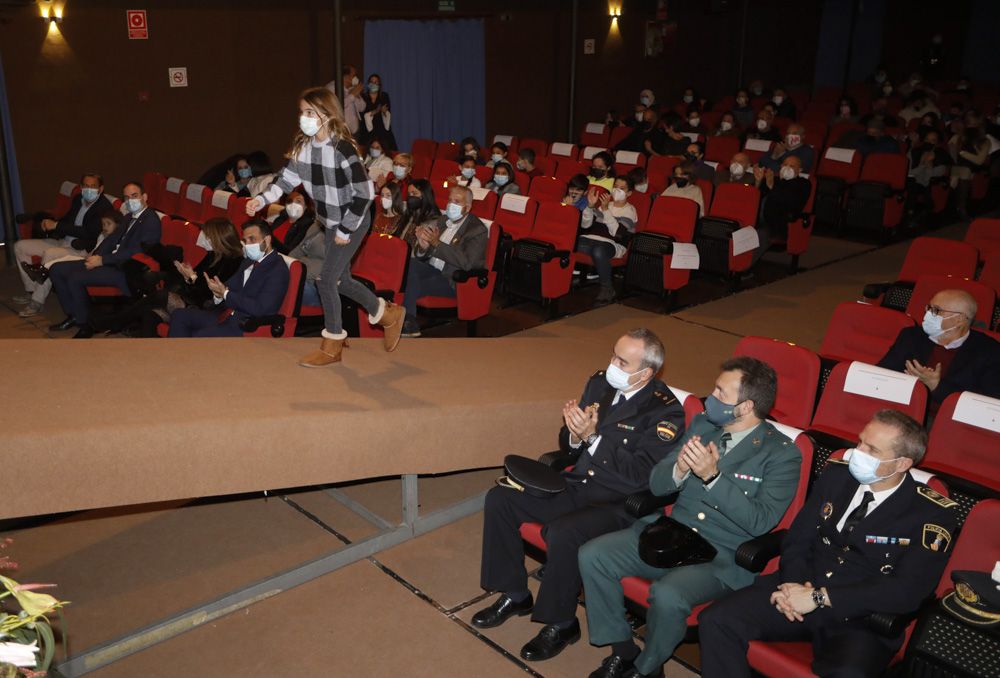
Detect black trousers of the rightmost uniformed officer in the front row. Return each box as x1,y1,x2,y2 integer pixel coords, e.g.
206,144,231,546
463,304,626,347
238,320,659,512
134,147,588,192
698,574,902,678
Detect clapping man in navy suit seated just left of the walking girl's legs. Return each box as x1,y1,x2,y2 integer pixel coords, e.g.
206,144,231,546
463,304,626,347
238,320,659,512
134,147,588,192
168,219,289,337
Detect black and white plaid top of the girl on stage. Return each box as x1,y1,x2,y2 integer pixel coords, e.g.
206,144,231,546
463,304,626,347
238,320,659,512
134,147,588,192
260,138,375,239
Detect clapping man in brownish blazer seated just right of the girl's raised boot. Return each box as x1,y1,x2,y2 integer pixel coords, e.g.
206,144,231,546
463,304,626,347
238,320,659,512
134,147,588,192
403,186,488,337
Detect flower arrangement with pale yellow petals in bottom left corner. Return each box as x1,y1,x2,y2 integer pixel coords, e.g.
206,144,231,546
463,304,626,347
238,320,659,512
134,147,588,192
0,538,67,678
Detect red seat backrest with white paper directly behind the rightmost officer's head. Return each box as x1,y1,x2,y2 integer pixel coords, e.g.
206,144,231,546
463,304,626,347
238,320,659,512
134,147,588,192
812,361,927,440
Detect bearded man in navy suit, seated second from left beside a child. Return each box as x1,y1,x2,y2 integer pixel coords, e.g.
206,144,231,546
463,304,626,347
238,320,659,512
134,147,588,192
49,181,160,339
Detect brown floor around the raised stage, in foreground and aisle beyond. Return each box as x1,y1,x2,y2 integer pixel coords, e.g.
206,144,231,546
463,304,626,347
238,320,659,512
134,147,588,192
0,226,964,678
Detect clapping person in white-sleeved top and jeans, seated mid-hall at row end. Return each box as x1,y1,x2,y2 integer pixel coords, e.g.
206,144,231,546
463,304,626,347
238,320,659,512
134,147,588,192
576,177,639,304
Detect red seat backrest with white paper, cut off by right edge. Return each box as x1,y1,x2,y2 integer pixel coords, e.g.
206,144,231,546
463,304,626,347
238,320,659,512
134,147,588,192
923,391,1000,491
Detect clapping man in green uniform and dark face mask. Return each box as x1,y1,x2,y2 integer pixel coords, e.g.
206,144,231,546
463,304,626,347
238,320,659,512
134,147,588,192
580,356,802,678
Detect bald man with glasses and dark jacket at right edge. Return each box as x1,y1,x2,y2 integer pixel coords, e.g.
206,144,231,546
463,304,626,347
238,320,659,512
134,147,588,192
878,290,1000,412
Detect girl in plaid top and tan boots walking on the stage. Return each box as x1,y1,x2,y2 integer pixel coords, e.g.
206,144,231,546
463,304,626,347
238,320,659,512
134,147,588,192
247,87,406,367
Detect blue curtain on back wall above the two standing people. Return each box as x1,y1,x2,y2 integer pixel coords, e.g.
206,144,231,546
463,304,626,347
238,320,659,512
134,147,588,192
361,19,487,150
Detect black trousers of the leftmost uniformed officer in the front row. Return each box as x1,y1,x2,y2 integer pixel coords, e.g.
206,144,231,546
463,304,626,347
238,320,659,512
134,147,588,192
480,483,633,624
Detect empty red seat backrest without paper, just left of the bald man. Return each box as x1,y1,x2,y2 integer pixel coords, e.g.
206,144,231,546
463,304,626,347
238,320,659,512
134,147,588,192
819,301,913,365
